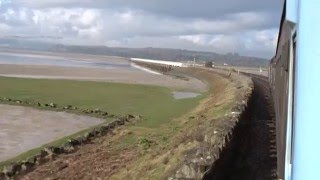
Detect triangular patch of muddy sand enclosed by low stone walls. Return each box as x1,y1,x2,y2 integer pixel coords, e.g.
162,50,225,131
0,104,103,162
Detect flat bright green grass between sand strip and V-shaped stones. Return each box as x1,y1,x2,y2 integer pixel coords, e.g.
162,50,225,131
0,77,203,127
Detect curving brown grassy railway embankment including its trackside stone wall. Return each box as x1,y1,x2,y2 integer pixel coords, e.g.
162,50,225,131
0,68,254,179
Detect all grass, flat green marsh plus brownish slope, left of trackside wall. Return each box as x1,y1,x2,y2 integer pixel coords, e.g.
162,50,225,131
0,68,250,179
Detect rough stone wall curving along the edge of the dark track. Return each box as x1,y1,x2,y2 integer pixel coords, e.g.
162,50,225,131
169,70,253,179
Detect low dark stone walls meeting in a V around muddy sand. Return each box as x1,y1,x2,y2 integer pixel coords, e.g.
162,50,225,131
0,98,140,180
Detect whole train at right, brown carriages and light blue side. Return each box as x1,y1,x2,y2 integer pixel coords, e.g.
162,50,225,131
269,0,320,180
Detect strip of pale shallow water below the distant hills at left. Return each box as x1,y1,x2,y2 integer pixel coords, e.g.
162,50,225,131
0,53,135,70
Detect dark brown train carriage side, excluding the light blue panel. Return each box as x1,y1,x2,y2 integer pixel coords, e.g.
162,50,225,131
269,2,296,179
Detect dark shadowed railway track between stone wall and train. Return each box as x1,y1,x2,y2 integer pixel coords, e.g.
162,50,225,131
205,74,277,180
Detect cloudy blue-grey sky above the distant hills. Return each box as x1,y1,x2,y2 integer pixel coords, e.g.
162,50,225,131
0,0,283,58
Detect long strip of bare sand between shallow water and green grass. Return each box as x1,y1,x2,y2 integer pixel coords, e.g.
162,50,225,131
0,64,207,92
